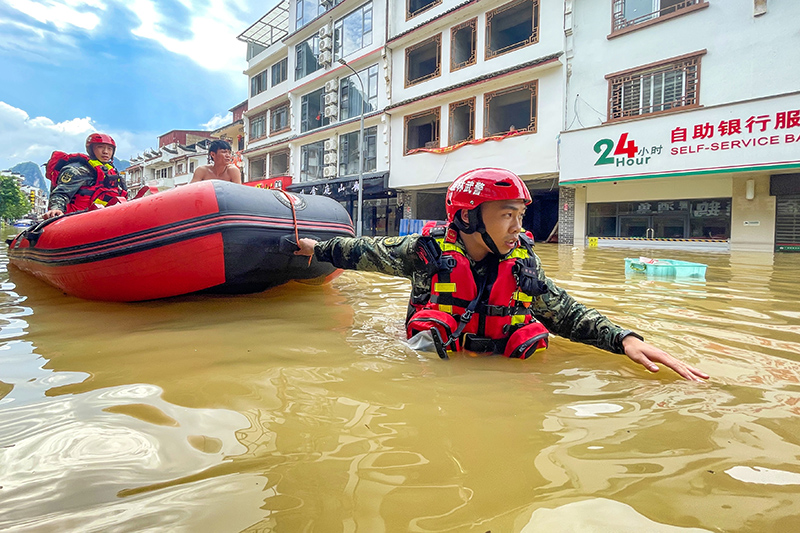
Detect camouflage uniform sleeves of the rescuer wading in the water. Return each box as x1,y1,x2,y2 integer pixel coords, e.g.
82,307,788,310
314,235,641,354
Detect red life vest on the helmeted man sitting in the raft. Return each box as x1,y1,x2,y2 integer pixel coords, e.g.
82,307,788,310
45,151,127,213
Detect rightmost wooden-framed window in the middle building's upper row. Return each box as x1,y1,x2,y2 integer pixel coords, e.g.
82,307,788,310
486,0,539,59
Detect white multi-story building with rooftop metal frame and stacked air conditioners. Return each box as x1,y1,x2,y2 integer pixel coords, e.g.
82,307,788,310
239,0,399,235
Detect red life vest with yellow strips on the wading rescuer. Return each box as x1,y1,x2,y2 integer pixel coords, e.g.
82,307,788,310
406,220,547,358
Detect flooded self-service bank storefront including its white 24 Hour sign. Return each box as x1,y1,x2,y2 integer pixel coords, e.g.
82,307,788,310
560,93,800,251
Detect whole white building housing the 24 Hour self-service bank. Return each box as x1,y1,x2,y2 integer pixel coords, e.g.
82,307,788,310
560,0,800,251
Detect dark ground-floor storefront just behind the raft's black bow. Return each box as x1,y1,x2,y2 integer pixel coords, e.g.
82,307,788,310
286,172,403,237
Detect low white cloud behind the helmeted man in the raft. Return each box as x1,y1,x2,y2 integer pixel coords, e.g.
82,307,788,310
0,101,158,169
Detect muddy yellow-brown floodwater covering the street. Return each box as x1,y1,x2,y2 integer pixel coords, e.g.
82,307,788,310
0,227,800,533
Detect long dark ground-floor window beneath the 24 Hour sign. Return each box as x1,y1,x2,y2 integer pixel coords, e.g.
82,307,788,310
586,198,731,239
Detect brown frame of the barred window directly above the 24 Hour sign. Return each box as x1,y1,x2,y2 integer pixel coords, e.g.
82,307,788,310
605,49,706,123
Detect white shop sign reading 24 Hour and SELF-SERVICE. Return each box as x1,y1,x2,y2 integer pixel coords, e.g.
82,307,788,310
561,94,800,182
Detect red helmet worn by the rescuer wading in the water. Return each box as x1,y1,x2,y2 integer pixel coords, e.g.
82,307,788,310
445,168,531,222
